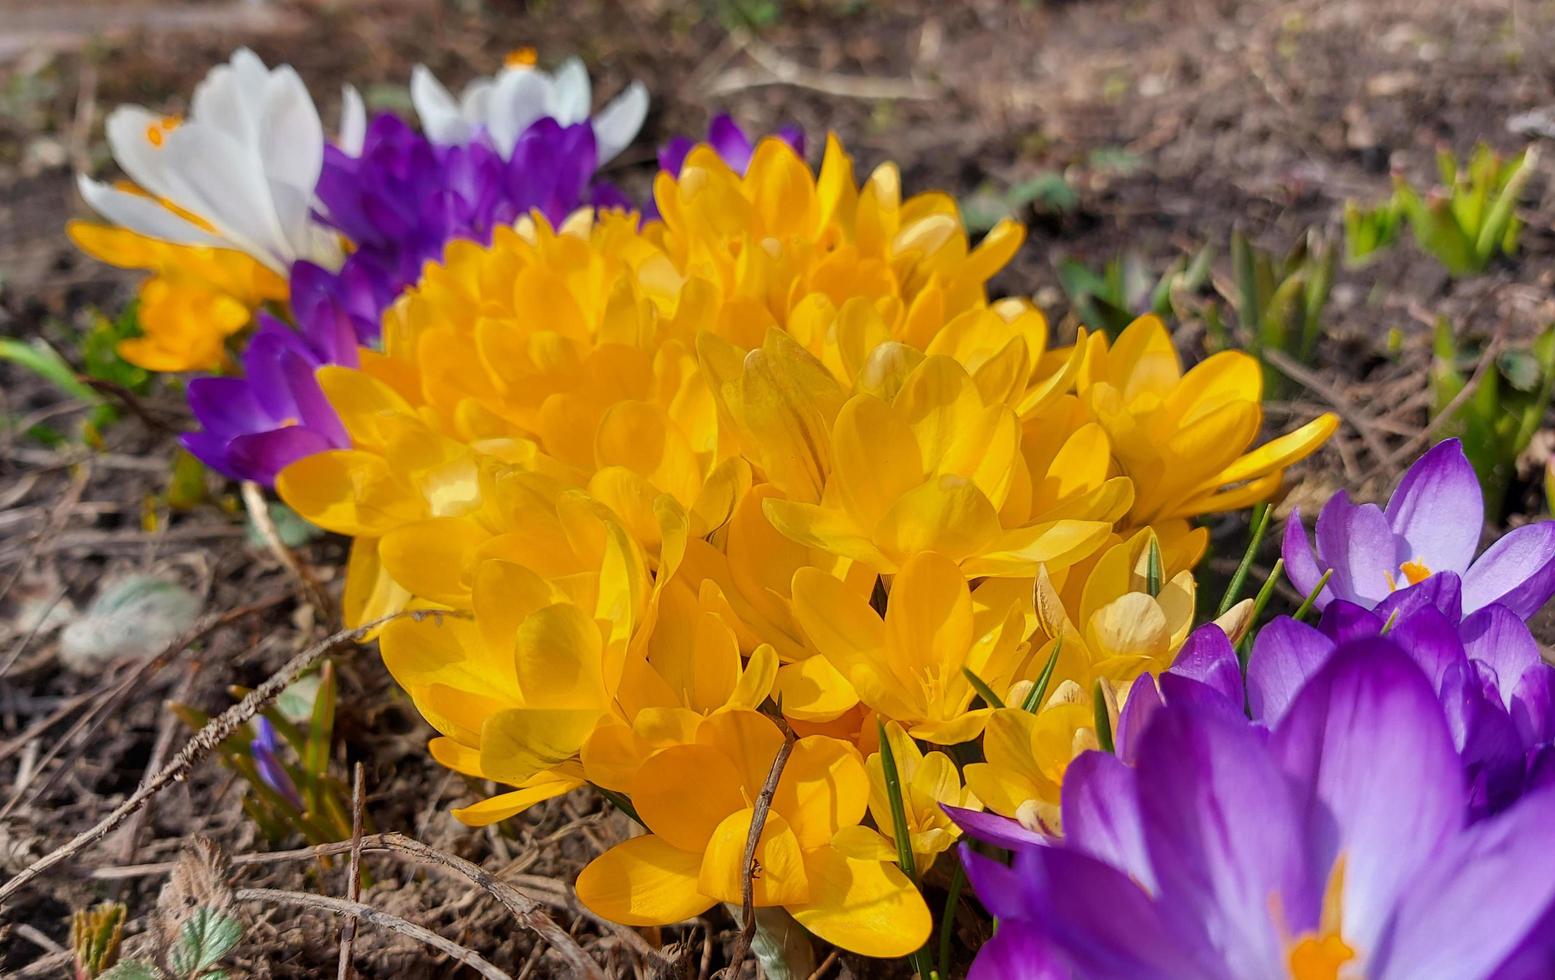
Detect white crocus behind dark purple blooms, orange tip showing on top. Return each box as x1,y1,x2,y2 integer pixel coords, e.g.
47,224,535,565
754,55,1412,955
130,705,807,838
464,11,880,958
411,58,648,163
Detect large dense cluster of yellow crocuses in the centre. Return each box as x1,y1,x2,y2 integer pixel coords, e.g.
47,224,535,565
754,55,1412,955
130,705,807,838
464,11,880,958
278,138,1334,957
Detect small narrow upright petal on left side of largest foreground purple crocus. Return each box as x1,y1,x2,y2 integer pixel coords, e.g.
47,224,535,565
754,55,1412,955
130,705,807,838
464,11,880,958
1062,751,1155,891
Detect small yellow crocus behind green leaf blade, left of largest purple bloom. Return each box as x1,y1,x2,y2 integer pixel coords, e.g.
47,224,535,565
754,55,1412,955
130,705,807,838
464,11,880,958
865,722,983,874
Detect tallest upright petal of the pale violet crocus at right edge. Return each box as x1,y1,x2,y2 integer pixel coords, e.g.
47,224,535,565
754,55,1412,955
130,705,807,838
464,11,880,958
1387,439,1485,574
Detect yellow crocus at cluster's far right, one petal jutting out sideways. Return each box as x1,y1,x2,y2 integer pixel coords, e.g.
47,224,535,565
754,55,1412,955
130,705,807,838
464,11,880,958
1078,316,1339,527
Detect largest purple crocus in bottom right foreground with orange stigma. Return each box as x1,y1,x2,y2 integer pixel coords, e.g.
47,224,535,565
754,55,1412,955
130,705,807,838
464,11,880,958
952,639,1555,980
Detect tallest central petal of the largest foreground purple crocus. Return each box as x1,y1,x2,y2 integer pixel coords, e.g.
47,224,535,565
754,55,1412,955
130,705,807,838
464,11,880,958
1270,639,1465,950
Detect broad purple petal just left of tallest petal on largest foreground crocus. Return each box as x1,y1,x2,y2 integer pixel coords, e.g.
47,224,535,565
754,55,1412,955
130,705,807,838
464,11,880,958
1137,703,1322,977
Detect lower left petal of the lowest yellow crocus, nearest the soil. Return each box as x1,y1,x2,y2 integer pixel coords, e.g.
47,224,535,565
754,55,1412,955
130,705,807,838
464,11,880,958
575,834,714,926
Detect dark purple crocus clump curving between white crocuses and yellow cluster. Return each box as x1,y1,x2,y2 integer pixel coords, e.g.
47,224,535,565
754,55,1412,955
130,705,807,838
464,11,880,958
183,114,618,485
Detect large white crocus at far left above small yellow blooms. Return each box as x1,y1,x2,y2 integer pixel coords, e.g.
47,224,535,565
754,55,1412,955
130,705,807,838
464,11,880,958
78,48,345,275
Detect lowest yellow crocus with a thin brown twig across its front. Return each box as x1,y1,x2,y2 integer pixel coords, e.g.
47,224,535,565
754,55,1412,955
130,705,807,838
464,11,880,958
577,711,931,957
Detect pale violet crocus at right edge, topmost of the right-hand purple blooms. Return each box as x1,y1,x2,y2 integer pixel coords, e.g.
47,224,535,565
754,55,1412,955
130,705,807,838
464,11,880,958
1283,439,1555,619
